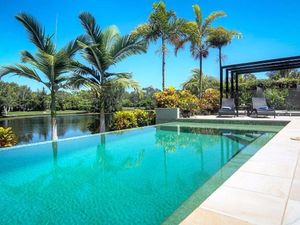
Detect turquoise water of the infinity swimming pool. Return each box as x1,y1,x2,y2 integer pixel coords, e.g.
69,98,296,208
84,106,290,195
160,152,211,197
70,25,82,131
0,123,281,225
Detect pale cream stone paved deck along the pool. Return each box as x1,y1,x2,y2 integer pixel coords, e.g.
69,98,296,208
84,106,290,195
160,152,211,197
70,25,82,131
181,116,300,225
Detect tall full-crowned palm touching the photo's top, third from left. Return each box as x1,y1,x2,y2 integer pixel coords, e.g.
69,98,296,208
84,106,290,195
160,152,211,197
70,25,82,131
132,1,185,90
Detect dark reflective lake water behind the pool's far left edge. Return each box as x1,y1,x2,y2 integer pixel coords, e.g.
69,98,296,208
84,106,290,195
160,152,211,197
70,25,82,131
0,115,99,145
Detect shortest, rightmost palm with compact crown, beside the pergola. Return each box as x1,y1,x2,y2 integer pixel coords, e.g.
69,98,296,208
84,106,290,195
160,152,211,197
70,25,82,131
207,27,241,73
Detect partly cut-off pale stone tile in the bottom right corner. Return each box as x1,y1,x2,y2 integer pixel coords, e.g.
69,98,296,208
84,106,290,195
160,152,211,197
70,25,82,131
282,200,300,225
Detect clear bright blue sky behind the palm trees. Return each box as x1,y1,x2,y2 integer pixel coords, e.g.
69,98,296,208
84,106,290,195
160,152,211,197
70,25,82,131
0,0,300,90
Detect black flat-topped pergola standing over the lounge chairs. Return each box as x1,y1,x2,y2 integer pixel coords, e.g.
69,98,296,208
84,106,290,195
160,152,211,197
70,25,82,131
220,56,300,106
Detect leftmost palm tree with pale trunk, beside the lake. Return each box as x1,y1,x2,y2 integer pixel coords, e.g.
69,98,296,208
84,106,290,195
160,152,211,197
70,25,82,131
0,13,82,141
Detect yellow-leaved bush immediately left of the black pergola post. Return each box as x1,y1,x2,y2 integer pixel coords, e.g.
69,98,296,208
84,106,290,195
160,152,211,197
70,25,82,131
200,88,220,114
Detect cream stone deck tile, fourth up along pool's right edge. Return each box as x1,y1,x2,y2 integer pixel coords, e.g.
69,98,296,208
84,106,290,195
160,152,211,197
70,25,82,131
240,159,296,178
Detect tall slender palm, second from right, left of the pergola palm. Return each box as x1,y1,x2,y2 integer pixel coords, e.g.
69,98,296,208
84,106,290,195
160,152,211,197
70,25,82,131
176,5,226,97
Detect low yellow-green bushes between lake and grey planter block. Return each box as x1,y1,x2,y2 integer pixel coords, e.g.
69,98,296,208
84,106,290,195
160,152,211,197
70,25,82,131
111,109,154,130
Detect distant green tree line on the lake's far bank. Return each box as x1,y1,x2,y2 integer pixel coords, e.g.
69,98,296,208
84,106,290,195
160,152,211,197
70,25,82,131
0,81,159,115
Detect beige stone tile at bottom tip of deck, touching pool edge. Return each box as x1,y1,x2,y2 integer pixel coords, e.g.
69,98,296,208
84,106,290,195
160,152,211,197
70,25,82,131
180,208,250,225
